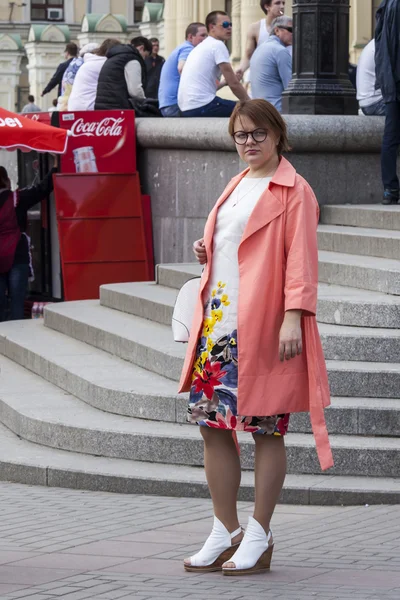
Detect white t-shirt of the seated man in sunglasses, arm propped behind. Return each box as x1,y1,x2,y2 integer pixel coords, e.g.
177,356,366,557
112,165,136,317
178,36,229,110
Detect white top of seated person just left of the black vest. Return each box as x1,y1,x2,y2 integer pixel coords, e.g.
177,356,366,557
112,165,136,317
68,52,107,110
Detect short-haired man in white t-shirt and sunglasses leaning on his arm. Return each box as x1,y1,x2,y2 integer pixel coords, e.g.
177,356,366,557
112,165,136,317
178,10,249,117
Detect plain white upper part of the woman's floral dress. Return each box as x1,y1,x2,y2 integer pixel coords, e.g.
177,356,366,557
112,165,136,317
202,176,272,326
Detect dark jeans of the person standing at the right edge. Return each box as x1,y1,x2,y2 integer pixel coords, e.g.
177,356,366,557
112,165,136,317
381,102,400,190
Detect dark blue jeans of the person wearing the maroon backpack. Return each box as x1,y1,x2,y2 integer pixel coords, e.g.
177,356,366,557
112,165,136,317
0,265,29,322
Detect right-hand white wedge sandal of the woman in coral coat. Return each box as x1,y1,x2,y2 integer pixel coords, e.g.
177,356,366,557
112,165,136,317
222,517,274,575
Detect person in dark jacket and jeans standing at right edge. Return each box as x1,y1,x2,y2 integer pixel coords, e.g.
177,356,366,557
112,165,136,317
375,0,400,204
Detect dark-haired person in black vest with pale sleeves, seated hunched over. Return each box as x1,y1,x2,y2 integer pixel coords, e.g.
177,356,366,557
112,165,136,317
94,36,152,110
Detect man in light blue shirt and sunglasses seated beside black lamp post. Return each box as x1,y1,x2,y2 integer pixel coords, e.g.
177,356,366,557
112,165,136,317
250,16,293,111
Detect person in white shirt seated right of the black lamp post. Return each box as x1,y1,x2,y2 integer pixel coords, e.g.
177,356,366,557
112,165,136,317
357,39,386,117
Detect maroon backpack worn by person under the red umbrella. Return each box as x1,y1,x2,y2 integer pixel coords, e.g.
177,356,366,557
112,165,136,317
0,190,21,274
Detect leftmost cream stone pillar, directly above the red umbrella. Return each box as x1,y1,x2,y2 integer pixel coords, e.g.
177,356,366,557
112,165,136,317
0,34,23,112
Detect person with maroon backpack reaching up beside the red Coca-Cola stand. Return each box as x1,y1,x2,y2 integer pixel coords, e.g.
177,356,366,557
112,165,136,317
0,158,58,322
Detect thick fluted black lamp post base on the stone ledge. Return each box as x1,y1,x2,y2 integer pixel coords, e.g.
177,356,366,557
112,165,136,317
282,0,358,115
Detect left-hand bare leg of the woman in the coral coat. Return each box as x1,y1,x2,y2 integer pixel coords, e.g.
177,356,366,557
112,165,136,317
184,426,243,565
